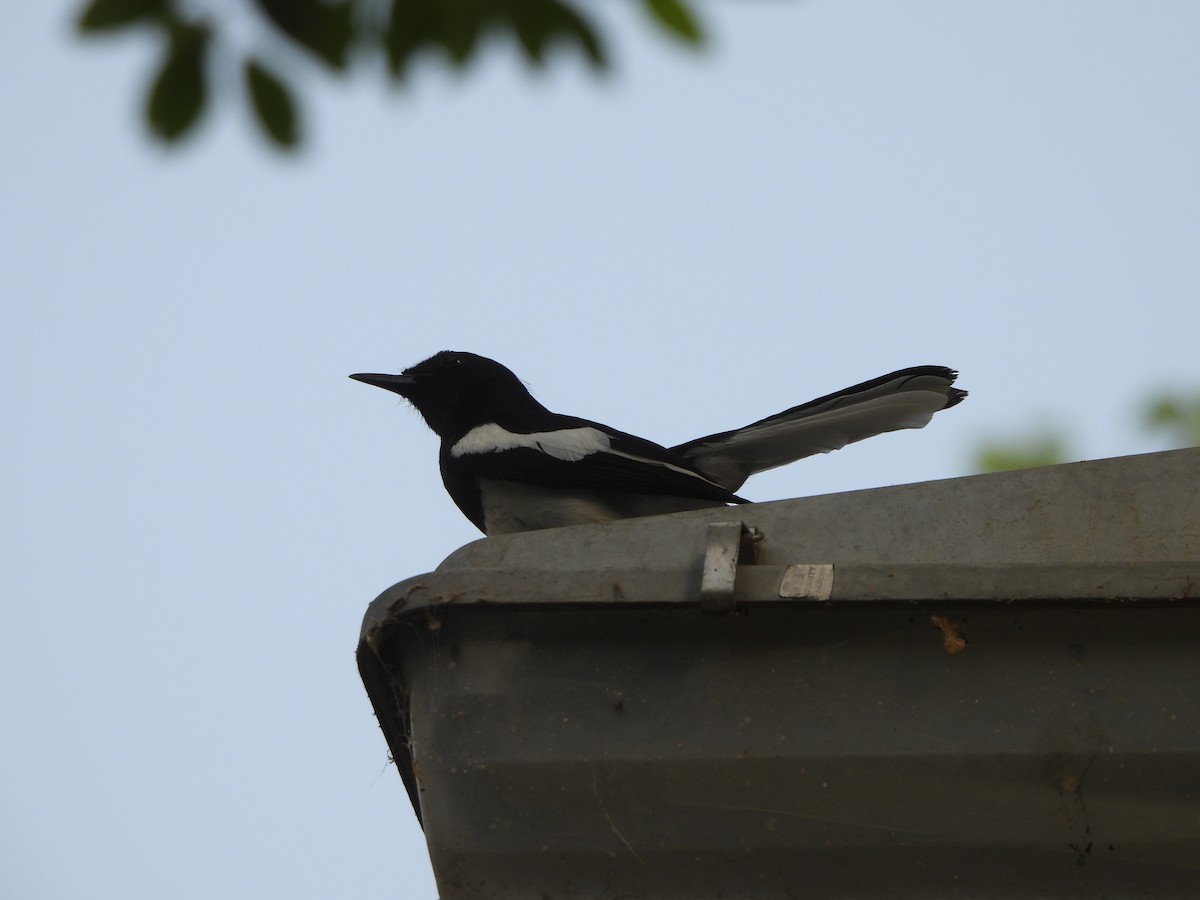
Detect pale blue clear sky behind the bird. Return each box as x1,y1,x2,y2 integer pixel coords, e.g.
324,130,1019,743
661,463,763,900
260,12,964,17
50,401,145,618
0,0,1200,900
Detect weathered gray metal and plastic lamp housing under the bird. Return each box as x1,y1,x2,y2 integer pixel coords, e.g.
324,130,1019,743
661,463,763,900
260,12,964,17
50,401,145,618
359,450,1200,900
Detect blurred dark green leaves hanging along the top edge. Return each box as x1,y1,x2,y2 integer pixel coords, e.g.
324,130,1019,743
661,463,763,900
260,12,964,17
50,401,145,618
77,0,704,149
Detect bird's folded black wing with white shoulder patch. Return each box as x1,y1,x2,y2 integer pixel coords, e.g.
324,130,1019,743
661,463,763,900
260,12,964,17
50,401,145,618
449,416,745,503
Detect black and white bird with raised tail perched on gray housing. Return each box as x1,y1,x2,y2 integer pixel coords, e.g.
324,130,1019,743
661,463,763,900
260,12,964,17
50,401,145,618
350,350,967,535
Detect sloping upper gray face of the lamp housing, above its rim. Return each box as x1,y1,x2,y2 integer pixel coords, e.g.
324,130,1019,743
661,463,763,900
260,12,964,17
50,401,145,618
427,449,1200,571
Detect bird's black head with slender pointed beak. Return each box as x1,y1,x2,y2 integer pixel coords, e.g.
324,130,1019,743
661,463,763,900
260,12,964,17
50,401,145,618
350,350,536,438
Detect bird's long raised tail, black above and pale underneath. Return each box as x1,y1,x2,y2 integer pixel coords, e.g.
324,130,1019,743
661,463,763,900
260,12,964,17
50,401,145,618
671,366,967,491
